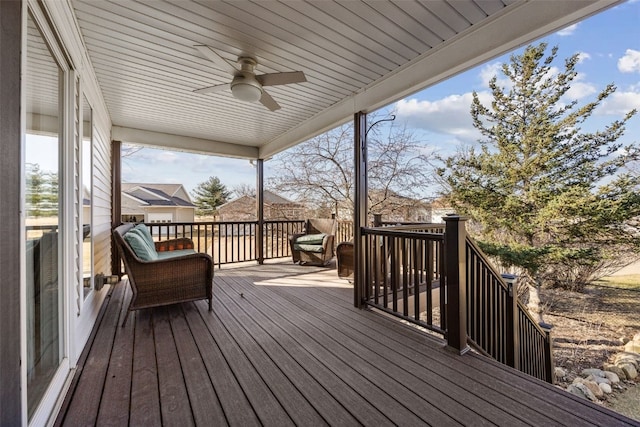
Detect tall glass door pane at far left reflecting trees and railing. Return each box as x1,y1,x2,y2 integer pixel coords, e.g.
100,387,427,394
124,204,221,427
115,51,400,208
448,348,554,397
25,11,63,417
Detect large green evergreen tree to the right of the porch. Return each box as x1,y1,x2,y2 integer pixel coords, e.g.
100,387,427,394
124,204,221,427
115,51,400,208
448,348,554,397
439,43,640,288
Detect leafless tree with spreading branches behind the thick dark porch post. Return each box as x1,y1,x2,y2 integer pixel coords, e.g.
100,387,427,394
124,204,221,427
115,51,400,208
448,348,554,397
267,114,432,218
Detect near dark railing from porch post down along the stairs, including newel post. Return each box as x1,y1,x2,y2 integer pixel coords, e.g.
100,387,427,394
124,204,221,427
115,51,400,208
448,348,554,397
362,216,553,383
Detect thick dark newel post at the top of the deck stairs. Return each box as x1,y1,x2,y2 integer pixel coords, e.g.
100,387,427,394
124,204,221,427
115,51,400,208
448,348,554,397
443,215,469,355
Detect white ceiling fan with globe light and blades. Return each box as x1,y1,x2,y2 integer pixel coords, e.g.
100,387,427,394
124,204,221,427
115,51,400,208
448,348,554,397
193,45,307,111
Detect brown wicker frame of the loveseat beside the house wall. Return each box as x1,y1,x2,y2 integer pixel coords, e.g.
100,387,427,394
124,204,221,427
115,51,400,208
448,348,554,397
113,224,213,326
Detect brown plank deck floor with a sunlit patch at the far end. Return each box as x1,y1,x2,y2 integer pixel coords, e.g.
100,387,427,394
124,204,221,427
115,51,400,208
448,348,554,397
56,263,640,427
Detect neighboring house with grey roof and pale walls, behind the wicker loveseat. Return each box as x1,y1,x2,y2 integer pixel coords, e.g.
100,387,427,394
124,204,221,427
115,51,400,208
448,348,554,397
122,183,196,223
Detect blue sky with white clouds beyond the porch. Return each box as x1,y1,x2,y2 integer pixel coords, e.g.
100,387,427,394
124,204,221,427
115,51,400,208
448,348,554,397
122,0,640,197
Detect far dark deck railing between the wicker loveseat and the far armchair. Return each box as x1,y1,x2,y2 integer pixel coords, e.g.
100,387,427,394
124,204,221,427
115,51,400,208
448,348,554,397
146,220,304,266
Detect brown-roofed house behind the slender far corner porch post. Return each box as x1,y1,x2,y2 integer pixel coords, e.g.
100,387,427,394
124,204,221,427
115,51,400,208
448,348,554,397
218,190,305,221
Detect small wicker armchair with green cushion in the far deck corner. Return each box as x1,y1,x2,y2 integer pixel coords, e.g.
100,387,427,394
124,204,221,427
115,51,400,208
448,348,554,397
289,218,338,266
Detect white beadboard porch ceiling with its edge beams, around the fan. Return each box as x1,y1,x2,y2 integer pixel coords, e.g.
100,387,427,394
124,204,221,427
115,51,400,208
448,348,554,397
71,0,618,158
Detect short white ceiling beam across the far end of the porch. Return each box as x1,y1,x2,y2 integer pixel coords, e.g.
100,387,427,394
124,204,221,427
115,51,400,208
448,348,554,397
111,126,258,159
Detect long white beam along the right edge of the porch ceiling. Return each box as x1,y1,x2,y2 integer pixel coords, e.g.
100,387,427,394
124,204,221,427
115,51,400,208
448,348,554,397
259,0,623,159
